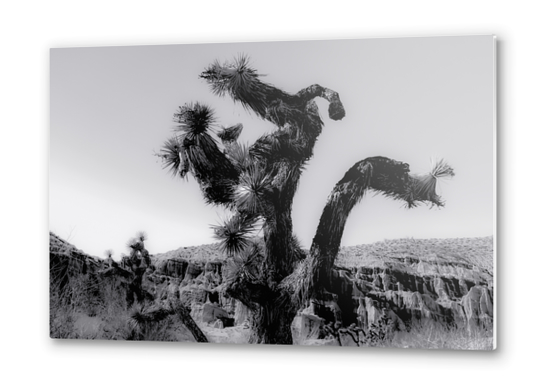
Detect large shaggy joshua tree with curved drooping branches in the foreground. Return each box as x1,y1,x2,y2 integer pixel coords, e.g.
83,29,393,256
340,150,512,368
160,56,453,344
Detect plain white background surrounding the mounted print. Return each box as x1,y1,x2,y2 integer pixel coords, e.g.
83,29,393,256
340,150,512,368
0,0,542,383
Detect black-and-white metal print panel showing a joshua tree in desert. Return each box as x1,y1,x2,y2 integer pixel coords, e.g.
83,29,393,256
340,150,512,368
49,36,495,350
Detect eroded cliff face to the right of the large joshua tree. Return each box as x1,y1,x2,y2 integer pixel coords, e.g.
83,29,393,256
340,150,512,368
293,237,493,343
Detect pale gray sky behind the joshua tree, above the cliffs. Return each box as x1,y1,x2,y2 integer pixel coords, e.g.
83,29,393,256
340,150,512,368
49,36,494,258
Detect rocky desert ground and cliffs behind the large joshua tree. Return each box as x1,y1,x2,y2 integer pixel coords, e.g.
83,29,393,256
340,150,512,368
50,233,493,350
